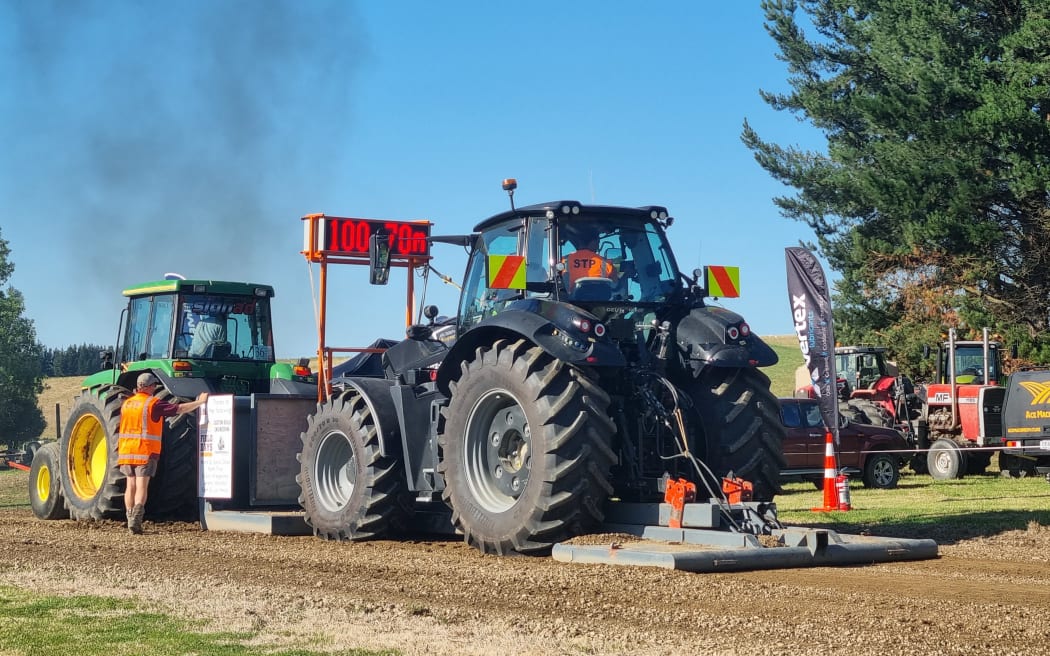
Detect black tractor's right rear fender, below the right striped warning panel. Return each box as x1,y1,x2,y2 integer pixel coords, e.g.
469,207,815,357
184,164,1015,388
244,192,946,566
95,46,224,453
675,306,779,375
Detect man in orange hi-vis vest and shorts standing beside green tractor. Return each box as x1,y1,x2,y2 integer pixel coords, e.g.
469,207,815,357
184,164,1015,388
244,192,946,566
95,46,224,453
117,372,208,535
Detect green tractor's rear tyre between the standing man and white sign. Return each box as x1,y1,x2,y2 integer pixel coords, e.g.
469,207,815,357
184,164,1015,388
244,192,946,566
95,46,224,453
146,389,197,520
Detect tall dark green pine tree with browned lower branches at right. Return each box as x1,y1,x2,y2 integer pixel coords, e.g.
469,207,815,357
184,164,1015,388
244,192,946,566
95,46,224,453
742,0,1050,369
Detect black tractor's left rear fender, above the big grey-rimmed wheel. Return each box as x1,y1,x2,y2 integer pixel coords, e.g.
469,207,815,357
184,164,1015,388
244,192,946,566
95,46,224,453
437,299,627,395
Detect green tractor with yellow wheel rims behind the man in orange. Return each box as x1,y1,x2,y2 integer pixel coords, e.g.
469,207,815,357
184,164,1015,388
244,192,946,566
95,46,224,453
29,274,317,520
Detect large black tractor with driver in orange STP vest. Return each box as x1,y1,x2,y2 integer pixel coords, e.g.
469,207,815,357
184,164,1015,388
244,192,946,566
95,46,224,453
298,181,784,553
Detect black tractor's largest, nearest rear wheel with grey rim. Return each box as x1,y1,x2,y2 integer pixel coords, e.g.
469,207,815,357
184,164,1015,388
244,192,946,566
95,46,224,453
438,340,615,554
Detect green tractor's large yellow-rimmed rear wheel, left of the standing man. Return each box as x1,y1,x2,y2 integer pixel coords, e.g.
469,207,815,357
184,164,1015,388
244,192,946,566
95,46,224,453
59,385,128,520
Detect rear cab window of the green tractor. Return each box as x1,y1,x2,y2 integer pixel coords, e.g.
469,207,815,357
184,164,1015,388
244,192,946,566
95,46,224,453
175,294,274,362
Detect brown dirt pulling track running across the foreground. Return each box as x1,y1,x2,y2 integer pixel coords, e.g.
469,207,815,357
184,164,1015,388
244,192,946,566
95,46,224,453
0,473,1050,656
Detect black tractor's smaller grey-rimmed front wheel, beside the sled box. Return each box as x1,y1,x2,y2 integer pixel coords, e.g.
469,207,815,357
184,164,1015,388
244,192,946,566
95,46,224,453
295,390,406,539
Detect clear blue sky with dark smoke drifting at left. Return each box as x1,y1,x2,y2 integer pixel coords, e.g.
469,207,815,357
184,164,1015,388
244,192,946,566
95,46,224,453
0,0,822,357
